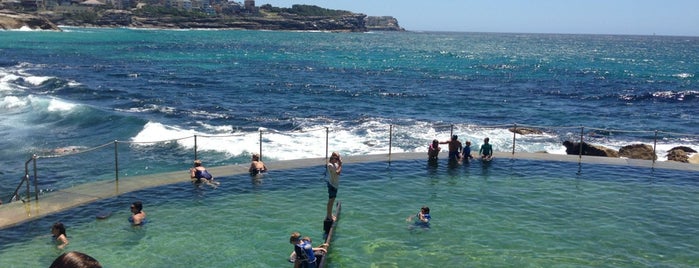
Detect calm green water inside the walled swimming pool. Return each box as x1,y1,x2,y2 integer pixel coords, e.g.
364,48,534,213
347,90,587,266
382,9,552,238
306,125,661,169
0,159,699,267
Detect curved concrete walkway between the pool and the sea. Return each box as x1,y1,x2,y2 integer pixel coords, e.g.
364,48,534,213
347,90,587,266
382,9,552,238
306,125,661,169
0,152,699,230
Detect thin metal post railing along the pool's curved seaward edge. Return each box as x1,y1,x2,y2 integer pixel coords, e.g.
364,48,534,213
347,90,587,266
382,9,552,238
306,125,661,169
8,123,699,202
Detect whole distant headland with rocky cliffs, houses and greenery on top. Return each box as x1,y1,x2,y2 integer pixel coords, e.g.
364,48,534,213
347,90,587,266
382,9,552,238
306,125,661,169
0,0,405,32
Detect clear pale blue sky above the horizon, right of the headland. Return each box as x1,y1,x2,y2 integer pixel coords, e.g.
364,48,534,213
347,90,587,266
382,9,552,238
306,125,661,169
260,0,699,36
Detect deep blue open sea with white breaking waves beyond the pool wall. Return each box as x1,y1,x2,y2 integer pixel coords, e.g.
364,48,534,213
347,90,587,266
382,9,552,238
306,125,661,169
0,28,699,266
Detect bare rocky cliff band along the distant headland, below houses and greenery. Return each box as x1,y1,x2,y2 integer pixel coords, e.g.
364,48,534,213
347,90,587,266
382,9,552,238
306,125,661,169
0,9,404,32
